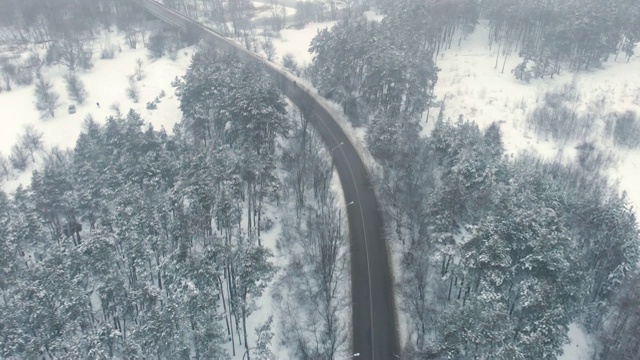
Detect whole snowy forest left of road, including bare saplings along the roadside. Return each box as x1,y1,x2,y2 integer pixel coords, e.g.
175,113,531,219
0,45,346,359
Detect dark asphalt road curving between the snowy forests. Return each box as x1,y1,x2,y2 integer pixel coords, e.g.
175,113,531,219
137,0,400,360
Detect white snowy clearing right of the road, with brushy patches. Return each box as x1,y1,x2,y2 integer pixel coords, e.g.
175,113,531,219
432,23,640,208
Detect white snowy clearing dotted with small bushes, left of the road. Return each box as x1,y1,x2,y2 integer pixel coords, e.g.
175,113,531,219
0,34,193,191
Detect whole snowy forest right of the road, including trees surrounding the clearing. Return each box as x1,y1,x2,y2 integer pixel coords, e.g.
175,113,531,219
308,0,640,359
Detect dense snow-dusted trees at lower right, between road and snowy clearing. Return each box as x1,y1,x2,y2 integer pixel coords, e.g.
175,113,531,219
368,119,640,359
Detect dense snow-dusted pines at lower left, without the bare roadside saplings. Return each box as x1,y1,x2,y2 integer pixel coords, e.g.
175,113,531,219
0,43,287,359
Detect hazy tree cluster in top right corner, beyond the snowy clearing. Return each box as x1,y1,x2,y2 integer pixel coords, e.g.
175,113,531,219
481,0,640,79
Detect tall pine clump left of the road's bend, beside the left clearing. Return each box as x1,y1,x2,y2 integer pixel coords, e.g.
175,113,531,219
177,45,289,239
